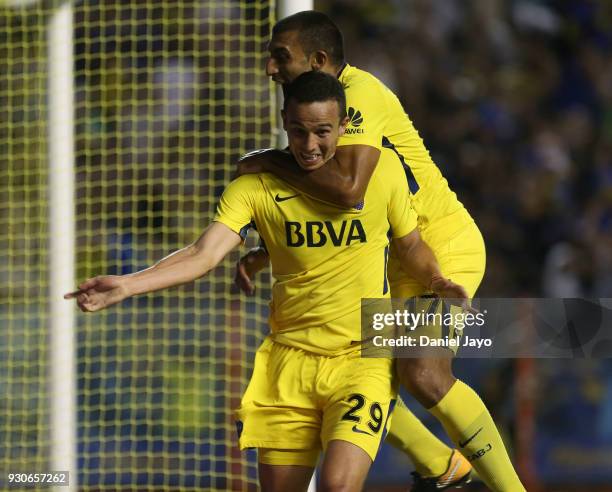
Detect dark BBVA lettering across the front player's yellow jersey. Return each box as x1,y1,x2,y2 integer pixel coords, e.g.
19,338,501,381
285,219,367,248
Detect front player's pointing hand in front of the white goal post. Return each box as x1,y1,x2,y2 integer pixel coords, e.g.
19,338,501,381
64,275,129,313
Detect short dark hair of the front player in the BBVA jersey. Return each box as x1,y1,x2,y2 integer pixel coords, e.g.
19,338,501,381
283,70,346,120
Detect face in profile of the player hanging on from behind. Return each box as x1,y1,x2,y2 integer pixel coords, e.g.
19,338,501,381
266,31,312,84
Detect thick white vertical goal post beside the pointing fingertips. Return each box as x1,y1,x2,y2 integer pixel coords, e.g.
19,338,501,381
47,1,77,492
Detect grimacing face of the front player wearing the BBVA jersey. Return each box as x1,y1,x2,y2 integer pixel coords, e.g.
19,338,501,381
283,100,347,171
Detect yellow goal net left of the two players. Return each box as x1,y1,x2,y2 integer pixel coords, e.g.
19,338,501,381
0,0,276,490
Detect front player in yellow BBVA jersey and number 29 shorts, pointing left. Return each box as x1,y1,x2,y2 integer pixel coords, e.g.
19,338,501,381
65,72,467,492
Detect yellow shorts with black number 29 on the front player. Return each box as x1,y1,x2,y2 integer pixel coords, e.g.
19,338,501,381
236,338,397,466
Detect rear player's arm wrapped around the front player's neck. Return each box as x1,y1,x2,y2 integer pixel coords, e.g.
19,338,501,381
238,145,380,208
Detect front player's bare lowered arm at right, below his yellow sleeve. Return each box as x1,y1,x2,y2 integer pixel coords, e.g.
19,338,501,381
393,229,469,308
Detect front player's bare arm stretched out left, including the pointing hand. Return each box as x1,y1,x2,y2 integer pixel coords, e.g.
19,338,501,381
64,222,241,312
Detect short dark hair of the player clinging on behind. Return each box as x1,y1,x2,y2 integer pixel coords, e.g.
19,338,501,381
272,10,344,67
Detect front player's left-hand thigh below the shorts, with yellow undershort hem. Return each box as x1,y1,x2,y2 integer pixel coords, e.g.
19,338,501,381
258,448,319,492
